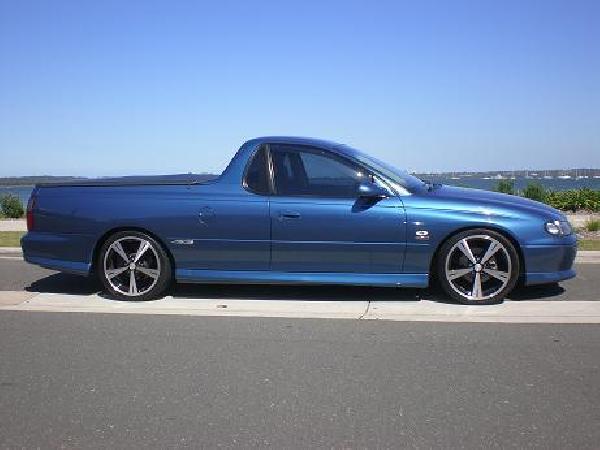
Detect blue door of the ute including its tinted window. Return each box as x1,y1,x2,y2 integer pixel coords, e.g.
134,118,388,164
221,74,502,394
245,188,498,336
269,144,405,273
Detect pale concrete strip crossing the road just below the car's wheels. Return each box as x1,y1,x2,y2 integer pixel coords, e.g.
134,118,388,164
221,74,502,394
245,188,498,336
0,291,600,323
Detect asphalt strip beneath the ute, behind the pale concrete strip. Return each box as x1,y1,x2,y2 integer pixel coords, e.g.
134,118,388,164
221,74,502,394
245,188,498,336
0,255,600,301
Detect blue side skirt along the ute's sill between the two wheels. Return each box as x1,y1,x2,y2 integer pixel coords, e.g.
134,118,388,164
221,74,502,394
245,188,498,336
175,269,429,288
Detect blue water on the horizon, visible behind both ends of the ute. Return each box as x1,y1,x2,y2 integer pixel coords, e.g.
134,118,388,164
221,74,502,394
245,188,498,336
0,176,600,205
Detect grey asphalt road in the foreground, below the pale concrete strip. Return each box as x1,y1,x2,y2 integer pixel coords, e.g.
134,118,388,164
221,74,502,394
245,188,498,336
0,311,600,449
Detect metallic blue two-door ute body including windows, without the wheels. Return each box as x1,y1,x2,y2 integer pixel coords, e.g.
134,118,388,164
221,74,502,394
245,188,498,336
22,137,576,301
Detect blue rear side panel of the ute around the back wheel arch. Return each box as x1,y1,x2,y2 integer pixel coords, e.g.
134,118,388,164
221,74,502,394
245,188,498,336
23,185,270,272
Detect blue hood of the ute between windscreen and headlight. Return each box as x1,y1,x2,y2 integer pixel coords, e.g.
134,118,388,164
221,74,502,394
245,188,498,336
428,185,564,220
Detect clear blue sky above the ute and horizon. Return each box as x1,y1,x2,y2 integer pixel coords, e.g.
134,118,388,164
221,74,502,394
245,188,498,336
0,0,600,176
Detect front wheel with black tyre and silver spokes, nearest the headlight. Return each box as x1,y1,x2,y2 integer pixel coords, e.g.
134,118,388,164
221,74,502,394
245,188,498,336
436,228,520,305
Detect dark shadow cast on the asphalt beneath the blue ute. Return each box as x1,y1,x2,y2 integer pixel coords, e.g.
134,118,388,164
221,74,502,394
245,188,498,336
25,273,565,304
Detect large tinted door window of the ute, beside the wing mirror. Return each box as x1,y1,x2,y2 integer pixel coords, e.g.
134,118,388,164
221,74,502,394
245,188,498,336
271,145,367,197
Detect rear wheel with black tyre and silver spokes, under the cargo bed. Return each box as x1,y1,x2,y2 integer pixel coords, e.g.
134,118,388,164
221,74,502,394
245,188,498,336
96,230,172,301
